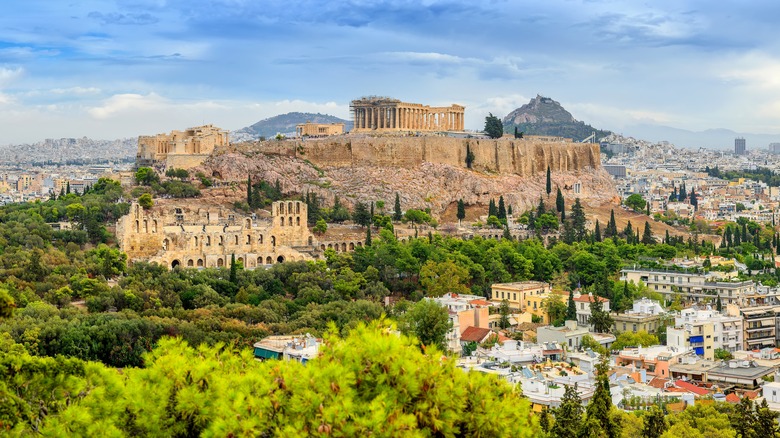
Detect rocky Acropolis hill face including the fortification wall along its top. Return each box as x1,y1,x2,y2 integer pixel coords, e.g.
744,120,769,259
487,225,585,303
202,136,616,214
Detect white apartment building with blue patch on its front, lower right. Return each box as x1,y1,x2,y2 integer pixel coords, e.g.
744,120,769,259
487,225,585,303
666,306,744,360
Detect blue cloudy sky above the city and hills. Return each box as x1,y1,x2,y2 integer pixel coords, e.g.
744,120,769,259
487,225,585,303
0,0,780,145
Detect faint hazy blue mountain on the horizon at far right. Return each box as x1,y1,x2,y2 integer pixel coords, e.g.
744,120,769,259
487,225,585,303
622,125,780,151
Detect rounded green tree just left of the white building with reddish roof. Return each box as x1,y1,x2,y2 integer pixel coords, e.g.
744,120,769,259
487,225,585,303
400,299,452,351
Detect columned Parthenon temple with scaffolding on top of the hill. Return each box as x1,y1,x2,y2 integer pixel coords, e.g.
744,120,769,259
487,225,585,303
350,96,465,132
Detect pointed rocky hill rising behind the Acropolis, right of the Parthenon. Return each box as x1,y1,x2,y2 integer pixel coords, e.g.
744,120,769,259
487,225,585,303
503,95,610,141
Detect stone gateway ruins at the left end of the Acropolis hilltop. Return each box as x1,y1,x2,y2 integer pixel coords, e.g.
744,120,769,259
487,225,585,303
136,125,228,169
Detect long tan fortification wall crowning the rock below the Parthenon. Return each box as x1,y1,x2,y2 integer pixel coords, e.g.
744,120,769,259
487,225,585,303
236,136,600,176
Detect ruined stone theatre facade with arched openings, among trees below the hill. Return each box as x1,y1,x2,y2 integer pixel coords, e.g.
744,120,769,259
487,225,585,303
116,201,363,269
